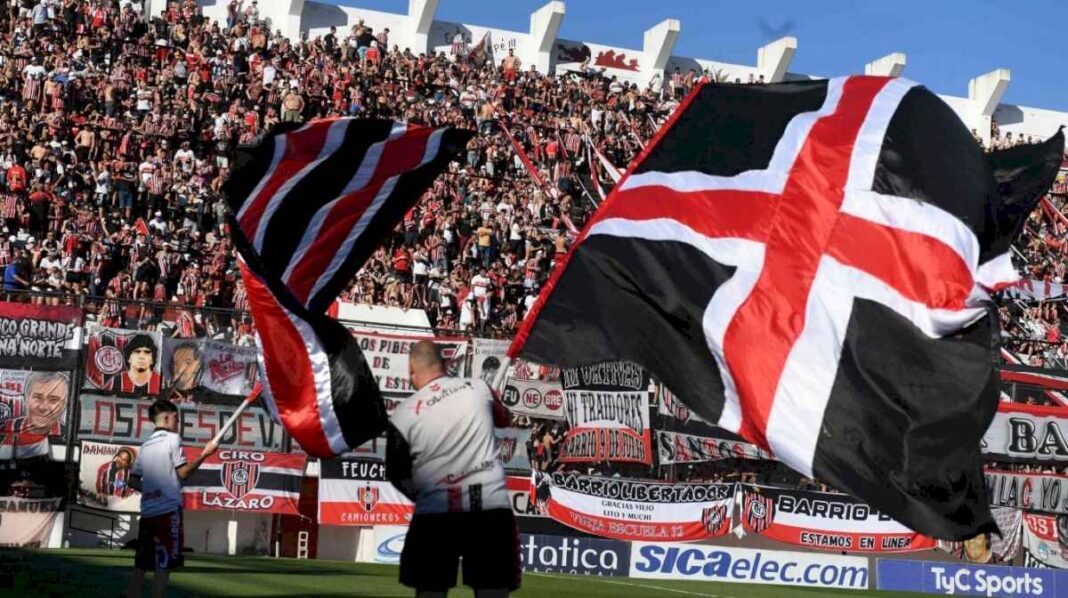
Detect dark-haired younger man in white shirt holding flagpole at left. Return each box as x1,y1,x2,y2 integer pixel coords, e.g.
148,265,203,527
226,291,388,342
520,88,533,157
126,398,218,598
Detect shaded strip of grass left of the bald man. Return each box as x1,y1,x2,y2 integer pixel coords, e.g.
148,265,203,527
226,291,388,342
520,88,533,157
0,549,408,596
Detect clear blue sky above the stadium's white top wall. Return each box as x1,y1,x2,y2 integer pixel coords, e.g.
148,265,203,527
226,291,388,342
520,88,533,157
320,0,1068,111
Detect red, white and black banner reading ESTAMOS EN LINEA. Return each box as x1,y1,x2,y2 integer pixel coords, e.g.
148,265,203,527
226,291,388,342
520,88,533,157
739,485,937,552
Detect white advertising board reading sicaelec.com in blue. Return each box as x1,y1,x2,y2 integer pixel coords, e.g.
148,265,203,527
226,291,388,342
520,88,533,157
630,542,868,596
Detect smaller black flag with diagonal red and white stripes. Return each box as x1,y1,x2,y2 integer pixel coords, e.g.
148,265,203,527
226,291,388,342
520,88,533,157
223,119,471,457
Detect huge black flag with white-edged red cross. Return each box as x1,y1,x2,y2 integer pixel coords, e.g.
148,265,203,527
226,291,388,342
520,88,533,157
508,77,1064,539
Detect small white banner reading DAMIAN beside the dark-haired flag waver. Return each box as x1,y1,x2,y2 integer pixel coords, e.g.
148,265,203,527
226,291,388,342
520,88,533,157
78,440,141,513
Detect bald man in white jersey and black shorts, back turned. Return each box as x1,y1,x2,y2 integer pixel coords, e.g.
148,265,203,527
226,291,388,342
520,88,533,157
386,341,521,598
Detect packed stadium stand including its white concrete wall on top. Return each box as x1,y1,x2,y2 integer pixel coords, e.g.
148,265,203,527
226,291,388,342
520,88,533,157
0,0,1068,576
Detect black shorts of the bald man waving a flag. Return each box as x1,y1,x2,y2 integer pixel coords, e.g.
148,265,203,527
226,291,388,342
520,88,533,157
401,508,522,592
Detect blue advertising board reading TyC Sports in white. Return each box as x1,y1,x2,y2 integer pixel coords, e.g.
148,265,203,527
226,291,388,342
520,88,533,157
877,558,1068,598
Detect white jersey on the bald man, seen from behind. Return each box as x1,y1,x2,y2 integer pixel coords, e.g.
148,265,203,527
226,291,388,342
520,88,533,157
390,377,512,513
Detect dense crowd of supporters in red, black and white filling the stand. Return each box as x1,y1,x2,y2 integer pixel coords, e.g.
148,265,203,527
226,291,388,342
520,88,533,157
0,0,1068,358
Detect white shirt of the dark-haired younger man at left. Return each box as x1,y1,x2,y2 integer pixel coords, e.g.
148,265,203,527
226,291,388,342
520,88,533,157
134,429,186,517
